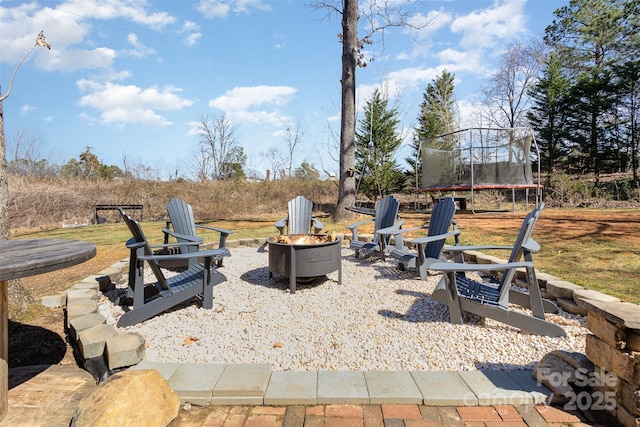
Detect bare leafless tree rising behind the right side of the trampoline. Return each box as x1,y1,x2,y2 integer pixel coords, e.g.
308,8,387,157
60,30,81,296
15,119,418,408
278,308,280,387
482,41,544,128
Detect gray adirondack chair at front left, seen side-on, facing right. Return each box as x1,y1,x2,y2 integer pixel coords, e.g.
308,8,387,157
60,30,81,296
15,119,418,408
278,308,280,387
118,208,227,327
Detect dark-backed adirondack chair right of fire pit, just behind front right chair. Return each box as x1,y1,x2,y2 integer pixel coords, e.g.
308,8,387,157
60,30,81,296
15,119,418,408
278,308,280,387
379,197,460,280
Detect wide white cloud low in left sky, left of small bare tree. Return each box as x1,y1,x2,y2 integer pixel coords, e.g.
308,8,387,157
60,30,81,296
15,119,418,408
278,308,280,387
76,80,193,127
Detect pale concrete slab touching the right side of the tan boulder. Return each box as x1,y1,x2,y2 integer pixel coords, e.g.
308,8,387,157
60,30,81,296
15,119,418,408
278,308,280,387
167,363,226,406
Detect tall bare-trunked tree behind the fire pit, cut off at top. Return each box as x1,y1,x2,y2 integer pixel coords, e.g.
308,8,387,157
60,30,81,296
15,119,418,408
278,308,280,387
313,0,428,221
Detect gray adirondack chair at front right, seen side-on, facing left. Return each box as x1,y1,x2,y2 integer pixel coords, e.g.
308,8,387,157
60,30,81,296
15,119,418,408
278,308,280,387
431,203,566,337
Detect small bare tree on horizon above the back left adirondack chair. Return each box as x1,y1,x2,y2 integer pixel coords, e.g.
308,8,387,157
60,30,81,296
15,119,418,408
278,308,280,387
198,114,242,179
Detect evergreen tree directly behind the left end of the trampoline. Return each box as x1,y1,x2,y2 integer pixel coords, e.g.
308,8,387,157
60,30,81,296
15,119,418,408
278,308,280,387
405,70,458,188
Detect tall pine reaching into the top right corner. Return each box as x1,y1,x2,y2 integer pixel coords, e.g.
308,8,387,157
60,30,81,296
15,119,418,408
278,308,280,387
545,0,640,182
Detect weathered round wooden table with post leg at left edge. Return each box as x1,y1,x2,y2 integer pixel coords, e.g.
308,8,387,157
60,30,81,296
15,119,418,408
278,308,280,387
0,239,96,420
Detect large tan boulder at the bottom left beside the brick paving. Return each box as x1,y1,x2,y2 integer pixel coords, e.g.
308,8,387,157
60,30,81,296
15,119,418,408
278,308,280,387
71,370,180,427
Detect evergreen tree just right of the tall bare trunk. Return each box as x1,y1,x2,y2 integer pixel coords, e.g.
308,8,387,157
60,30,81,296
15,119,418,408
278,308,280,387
355,89,404,200
